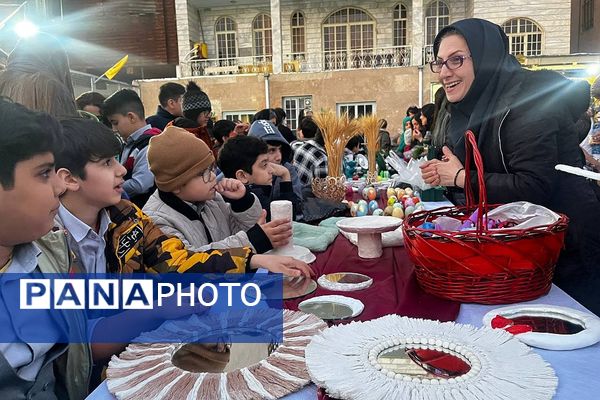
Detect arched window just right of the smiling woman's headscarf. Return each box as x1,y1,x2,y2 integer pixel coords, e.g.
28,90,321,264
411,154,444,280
502,18,542,56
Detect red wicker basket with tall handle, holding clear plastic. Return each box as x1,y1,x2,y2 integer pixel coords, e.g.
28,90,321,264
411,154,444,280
403,131,568,304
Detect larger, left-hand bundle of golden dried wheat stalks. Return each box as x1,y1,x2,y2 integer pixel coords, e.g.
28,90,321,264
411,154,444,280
313,110,360,177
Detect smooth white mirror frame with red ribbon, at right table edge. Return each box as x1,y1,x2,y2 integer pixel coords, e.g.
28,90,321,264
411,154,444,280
483,304,600,350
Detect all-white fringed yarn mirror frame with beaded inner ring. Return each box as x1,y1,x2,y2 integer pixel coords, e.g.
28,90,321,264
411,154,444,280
305,315,558,400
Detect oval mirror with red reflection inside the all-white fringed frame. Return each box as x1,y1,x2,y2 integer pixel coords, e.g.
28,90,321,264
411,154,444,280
377,345,471,379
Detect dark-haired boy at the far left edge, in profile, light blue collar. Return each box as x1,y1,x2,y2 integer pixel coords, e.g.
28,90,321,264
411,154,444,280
0,98,91,400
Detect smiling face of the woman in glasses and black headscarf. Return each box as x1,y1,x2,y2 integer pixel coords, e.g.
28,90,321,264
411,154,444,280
437,35,475,103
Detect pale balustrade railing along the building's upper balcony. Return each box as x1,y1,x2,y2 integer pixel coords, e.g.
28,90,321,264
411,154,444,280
183,46,412,76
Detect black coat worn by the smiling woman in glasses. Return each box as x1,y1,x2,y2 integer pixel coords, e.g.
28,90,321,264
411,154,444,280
450,71,600,313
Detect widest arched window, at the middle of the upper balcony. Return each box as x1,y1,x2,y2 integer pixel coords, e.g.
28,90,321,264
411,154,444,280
323,7,375,69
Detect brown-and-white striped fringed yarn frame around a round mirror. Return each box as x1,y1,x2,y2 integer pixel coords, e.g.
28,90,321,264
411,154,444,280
106,310,327,400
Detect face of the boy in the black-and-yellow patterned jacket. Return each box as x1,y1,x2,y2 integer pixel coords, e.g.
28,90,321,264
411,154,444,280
68,157,127,211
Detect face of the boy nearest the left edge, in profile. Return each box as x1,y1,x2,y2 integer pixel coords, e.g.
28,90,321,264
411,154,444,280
0,152,65,246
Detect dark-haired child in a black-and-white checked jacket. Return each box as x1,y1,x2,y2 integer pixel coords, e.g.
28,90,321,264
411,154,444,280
292,117,327,186
